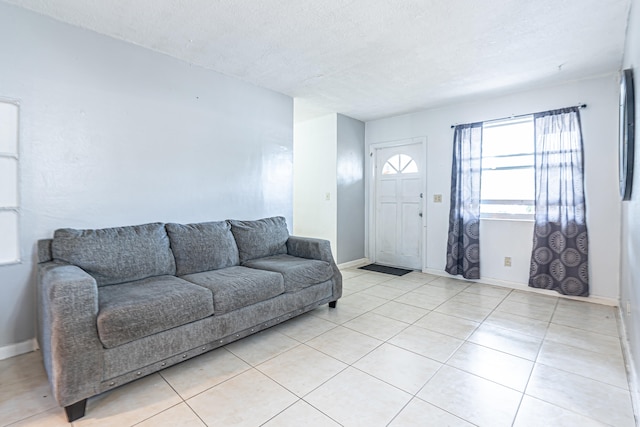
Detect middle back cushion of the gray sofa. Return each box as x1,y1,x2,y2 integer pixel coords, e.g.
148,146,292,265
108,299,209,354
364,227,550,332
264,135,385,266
166,221,240,276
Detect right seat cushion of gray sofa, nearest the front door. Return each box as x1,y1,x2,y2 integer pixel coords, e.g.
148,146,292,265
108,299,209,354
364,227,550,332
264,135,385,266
243,255,333,292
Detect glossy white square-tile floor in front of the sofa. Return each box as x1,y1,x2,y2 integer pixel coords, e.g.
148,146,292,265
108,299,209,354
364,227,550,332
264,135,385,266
0,269,635,427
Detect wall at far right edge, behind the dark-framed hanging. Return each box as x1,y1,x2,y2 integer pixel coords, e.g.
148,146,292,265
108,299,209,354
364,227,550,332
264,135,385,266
620,2,640,394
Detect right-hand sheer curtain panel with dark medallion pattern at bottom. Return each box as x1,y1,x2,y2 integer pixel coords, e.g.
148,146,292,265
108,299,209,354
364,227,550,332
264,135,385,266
529,107,589,296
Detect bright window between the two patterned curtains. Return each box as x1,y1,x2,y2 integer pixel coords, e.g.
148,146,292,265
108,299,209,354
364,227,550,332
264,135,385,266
480,116,535,219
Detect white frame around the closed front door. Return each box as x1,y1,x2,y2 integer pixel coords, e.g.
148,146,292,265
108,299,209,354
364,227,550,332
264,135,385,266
366,136,427,271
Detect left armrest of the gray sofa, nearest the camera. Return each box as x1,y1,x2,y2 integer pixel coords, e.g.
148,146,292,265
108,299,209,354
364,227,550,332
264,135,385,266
38,262,103,406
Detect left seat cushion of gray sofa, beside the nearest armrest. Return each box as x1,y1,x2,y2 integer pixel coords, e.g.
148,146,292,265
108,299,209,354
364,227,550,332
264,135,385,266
98,276,213,348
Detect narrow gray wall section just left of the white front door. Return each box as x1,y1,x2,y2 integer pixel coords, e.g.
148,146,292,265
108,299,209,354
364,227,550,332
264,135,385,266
336,114,364,264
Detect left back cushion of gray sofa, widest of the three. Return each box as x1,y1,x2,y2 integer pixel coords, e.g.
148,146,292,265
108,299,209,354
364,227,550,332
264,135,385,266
51,223,176,286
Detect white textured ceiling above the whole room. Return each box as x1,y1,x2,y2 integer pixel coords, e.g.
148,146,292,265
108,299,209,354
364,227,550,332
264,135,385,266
4,0,632,121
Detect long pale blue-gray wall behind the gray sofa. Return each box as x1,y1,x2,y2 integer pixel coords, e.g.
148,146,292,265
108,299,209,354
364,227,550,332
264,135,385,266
0,3,293,349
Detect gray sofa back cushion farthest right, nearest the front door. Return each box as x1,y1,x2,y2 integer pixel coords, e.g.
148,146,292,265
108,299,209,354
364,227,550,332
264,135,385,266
229,216,289,263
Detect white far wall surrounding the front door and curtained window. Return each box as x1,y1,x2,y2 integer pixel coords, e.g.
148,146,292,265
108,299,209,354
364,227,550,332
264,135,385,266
365,74,620,303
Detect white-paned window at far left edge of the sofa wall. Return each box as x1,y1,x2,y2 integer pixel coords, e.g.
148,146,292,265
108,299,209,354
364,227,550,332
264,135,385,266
0,101,20,264
